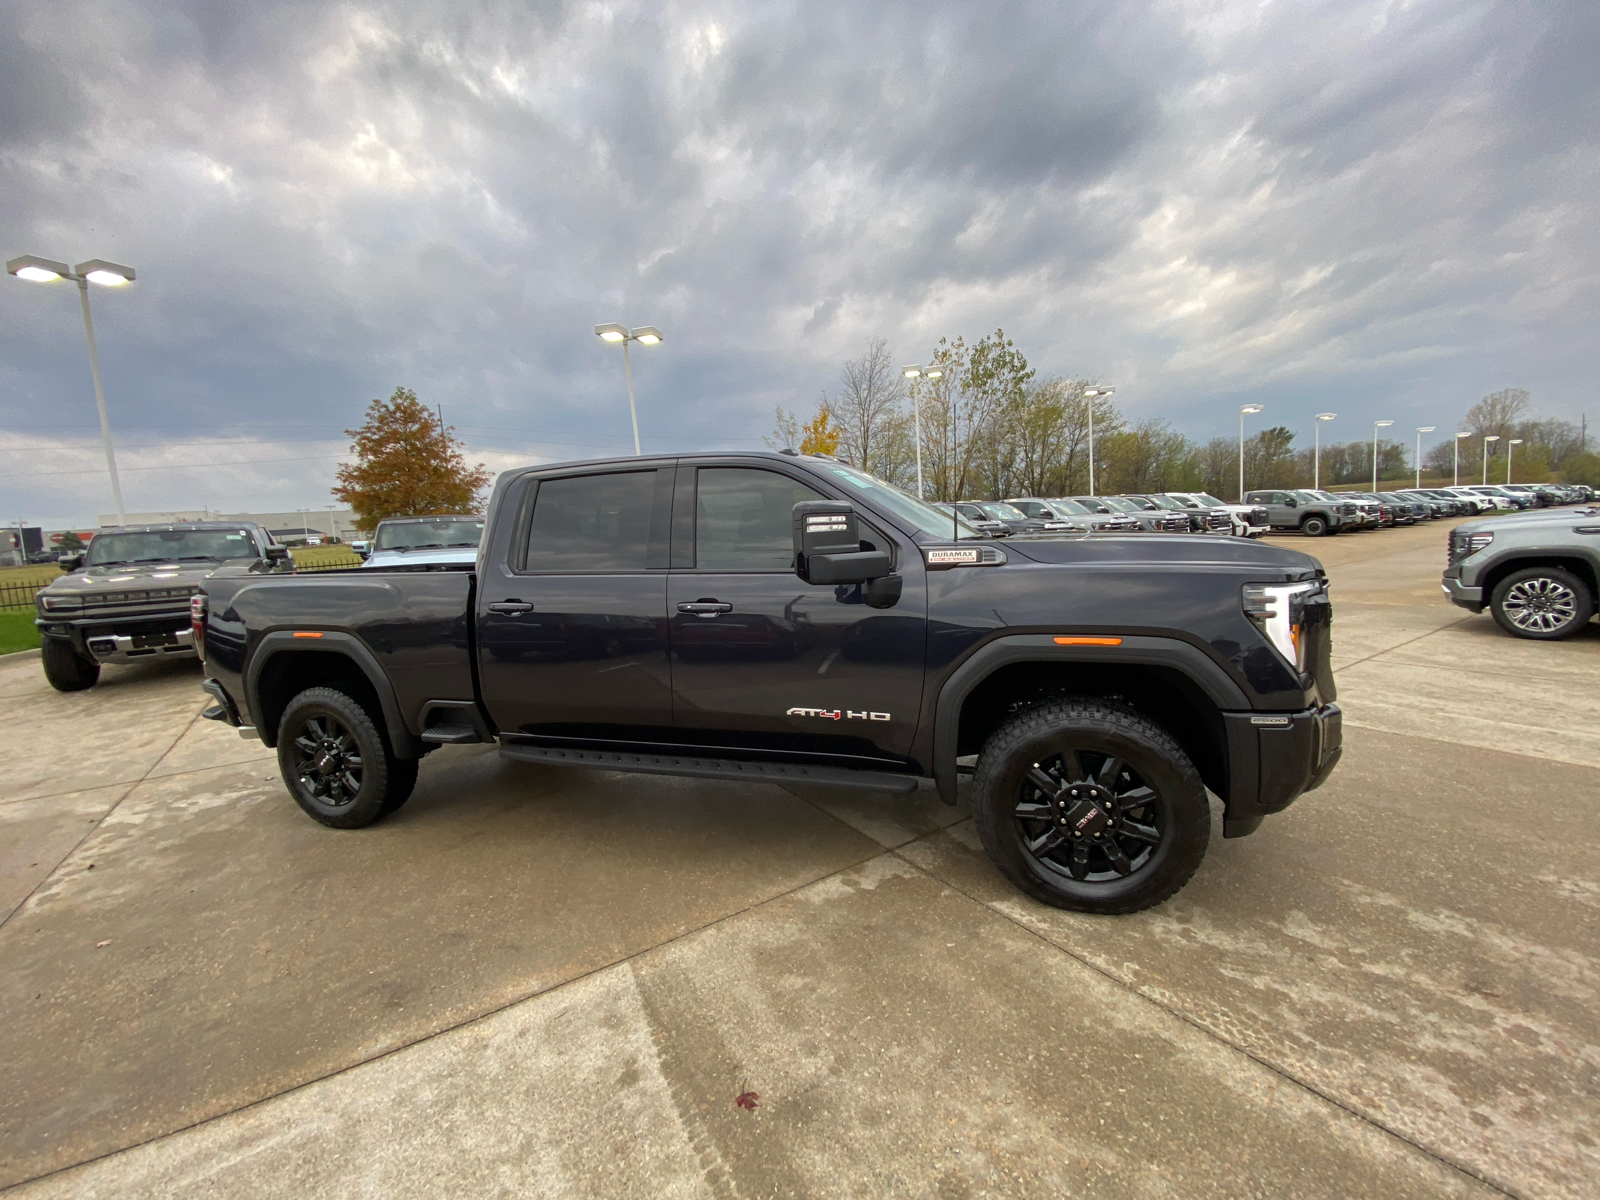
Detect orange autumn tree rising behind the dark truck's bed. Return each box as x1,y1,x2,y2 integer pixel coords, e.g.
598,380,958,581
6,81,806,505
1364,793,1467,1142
333,387,491,530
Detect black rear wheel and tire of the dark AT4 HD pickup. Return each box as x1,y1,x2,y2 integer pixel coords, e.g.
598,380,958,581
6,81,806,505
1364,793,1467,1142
278,688,416,829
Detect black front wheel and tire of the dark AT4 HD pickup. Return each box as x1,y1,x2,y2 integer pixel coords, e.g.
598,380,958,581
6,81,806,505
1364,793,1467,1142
973,698,1211,914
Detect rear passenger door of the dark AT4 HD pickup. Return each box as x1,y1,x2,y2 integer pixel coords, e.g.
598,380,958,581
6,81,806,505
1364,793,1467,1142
478,467,674,741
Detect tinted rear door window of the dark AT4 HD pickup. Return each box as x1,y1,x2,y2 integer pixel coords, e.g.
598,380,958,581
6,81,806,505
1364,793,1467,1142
525,470,656,574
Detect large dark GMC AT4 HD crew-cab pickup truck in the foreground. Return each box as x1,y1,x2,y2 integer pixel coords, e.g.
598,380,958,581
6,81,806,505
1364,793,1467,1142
203,454,1341,912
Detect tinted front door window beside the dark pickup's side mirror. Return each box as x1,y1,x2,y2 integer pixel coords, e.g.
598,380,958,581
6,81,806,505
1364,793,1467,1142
694,467,826,571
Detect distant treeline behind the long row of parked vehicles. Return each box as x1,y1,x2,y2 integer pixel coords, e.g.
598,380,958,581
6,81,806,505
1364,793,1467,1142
768,342,1600,499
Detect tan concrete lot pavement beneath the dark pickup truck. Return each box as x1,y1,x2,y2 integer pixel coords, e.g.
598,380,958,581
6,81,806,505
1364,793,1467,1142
0,523,1600,1198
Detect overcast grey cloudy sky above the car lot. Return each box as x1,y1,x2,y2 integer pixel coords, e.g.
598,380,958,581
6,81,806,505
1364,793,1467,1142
0,0,1600,525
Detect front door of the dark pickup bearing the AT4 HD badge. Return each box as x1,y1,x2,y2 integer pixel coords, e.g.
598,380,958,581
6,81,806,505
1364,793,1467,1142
667,462,928,765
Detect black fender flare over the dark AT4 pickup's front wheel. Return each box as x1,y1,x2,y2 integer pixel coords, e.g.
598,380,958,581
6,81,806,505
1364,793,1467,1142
933,634,1254,805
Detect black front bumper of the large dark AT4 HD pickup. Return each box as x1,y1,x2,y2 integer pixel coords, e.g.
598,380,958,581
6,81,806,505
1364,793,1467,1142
1222,704,1344,837
